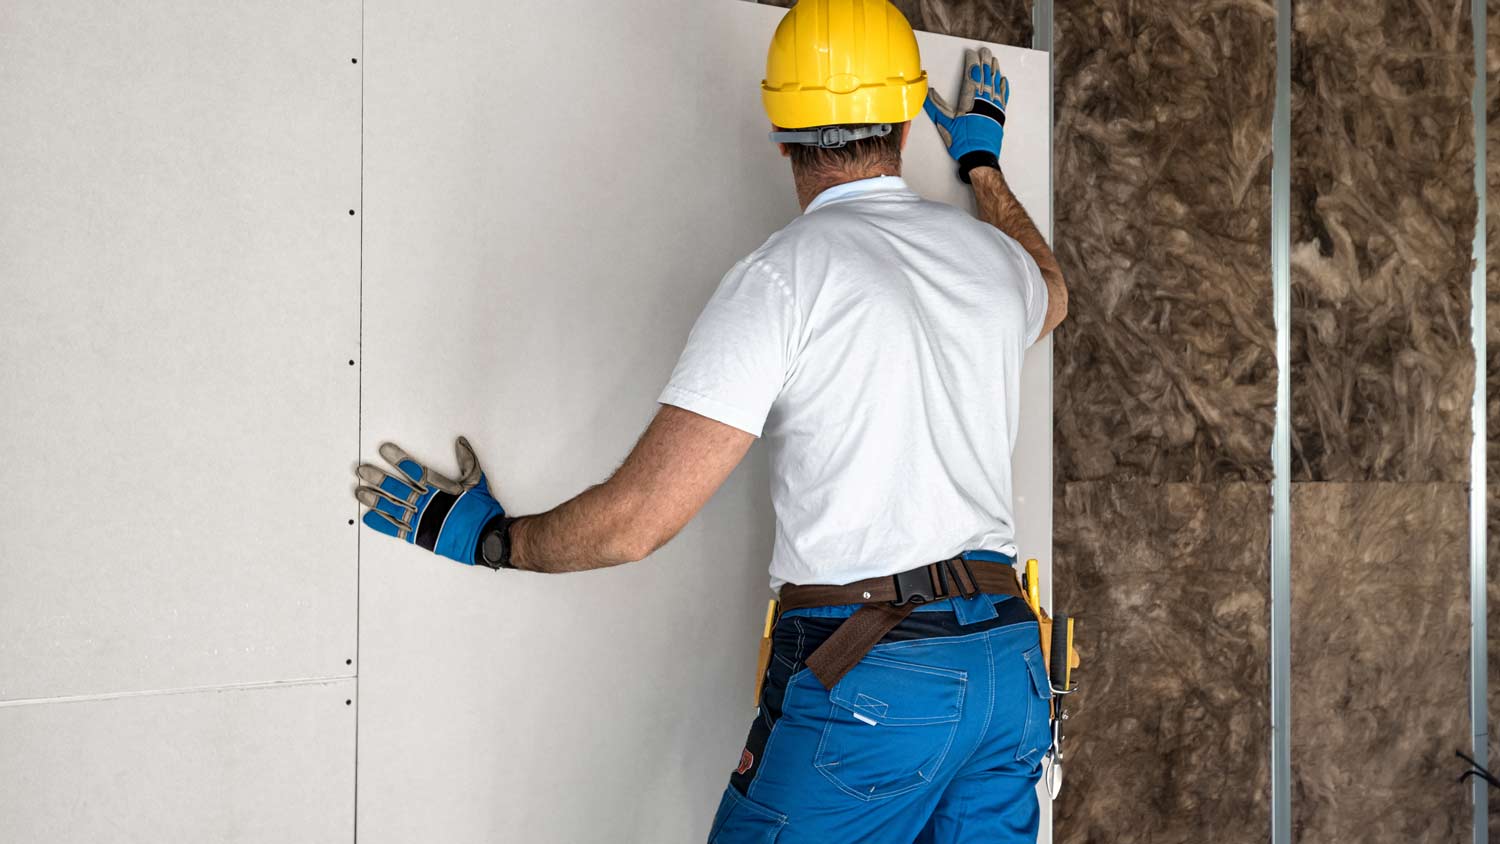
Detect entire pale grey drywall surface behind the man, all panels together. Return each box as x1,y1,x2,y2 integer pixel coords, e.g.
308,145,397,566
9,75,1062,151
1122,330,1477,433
0,0,1052,843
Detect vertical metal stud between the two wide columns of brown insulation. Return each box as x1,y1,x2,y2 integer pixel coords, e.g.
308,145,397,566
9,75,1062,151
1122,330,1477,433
1271,0,1296,844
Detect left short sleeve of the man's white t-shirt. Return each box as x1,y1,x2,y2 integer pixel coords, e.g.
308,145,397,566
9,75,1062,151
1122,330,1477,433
657,261,800,436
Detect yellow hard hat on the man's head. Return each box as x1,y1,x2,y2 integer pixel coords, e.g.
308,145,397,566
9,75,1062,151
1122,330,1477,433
761,0,927,129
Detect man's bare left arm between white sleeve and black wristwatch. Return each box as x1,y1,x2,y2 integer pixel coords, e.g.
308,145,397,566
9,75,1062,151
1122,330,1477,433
510,405,755,573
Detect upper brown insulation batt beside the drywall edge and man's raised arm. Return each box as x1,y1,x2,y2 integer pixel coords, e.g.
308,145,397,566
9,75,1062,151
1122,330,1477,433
1053,0,1277,483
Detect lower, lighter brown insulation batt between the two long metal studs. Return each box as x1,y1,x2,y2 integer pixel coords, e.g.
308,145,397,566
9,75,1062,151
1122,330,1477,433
1290,483,1470,843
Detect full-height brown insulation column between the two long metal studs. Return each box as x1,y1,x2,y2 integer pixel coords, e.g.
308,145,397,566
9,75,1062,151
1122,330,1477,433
1292,0,1475,841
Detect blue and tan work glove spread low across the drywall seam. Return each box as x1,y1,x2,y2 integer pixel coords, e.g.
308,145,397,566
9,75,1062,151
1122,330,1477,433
354,436,506,565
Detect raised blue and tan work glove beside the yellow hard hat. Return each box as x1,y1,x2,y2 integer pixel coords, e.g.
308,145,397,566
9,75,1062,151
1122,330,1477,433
923,46,1011,183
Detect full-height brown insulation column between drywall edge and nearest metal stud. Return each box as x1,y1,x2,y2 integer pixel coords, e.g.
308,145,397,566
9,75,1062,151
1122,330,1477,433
1053,0,1277,843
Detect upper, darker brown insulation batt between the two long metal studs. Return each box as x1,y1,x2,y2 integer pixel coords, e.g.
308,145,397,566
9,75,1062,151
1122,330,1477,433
1292,0,1475,481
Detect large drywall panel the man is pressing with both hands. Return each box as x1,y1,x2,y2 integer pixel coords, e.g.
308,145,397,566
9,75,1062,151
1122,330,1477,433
359,0,1050,844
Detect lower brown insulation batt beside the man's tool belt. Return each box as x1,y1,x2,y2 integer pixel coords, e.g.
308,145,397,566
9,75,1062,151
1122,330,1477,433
1053,481,1271,844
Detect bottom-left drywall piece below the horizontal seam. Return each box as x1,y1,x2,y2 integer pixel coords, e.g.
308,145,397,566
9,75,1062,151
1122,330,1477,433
0,679,354,844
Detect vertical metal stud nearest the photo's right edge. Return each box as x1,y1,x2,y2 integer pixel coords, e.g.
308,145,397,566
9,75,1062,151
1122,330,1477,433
1469,0,1490,844
